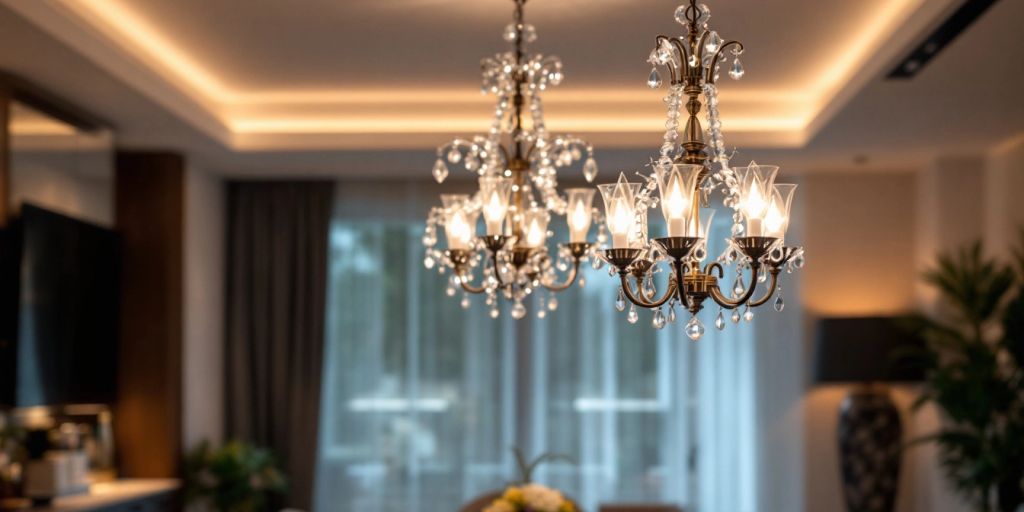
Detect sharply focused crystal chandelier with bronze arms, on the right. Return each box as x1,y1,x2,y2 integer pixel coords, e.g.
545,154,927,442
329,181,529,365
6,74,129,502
598,0,804,340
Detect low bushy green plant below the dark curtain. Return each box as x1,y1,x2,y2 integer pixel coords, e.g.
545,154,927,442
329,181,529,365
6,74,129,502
185,441,287,512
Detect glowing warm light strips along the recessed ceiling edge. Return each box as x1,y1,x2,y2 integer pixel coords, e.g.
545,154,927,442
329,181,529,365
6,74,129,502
39,0,924,143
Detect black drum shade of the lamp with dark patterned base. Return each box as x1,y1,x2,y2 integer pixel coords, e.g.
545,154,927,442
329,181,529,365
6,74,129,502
814,316,925,383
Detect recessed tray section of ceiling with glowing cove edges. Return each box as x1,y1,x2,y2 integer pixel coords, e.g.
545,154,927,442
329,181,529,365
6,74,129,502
5,0,955,151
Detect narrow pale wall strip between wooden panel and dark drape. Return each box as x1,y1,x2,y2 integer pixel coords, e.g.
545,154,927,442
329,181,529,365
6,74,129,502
182,168,225,450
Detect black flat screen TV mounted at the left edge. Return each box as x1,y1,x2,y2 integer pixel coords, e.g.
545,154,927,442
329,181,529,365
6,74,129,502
0,205,121,408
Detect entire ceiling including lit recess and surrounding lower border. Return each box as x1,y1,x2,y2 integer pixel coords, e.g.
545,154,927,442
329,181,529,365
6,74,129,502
0,0,1024,176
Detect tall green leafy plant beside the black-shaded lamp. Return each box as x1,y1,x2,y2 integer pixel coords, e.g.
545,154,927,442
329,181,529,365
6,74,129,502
911,237,1024,512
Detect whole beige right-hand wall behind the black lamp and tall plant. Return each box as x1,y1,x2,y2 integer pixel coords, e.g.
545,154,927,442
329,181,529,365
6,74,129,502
802,136,1024,512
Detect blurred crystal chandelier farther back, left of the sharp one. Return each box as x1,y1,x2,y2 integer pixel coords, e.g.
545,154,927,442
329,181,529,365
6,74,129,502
423,0,606,319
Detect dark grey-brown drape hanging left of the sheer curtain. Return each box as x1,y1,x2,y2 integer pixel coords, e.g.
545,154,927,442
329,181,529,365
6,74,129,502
225,181,334,510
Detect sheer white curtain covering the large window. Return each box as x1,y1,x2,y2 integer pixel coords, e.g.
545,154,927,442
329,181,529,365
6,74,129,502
316,183,782,512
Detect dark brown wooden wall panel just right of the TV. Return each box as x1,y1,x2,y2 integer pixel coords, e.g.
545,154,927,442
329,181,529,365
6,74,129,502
114,153,185,477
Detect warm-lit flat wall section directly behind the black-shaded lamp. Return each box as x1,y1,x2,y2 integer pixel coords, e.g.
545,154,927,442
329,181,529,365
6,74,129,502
800,171,918,511
